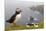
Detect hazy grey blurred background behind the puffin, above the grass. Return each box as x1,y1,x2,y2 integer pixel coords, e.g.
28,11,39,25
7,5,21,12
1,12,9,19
5,0,44,25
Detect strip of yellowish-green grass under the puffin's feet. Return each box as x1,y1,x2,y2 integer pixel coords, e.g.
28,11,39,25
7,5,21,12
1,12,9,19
5,23,44,31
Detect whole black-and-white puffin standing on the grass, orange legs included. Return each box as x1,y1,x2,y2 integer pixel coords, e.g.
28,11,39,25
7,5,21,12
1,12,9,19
6,8,22,25
